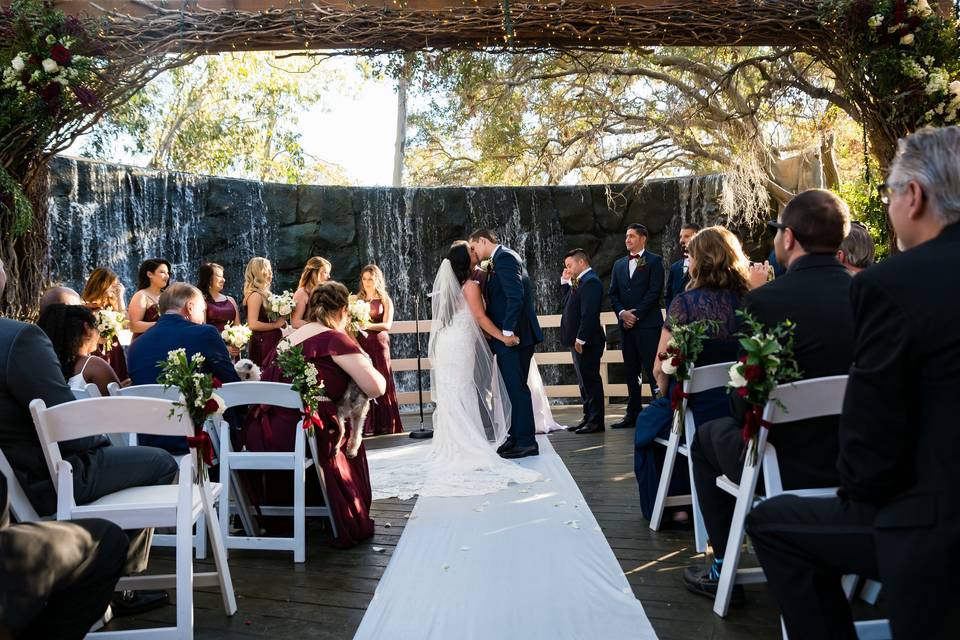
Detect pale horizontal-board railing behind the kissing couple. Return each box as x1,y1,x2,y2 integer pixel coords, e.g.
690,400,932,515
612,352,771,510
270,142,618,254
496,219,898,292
390,311,650,404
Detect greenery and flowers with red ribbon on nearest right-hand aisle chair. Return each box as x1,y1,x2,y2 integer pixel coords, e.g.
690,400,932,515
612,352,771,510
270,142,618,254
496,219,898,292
727,311,803,465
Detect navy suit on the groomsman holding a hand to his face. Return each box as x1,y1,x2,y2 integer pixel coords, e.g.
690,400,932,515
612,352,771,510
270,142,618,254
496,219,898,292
560,269,607,426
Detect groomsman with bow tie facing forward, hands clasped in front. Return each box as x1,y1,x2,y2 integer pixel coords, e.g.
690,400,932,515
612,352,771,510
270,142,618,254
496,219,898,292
610,224,663,429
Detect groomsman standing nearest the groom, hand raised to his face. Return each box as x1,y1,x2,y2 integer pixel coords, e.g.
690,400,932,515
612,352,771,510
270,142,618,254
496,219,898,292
560,249,607,433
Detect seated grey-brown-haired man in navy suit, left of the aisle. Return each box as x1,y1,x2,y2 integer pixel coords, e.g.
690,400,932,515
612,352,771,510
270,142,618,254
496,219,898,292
127,282,240,454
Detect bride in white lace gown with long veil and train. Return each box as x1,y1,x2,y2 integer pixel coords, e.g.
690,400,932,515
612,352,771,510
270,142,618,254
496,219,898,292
368,242,541,500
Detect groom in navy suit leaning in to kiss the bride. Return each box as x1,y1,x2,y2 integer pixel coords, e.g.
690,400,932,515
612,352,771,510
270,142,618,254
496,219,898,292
470,229,543,458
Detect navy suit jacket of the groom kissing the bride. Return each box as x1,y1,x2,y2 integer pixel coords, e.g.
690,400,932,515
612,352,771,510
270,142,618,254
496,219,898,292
486,246,543,347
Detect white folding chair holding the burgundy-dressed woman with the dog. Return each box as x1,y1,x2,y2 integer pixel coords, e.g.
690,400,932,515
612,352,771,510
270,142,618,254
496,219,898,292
217,382,337,562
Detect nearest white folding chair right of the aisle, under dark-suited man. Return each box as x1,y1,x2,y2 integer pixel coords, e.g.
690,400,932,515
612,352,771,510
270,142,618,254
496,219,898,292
713,376,847,617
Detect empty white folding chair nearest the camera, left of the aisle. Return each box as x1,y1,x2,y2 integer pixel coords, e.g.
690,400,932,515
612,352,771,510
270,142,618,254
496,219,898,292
30,398,237,639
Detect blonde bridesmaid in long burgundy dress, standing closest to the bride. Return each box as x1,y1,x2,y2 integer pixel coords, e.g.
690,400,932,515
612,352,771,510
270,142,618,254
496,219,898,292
357,264,403,436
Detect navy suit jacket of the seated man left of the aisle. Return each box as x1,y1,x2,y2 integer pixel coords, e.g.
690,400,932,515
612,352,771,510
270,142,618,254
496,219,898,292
127,313,240,454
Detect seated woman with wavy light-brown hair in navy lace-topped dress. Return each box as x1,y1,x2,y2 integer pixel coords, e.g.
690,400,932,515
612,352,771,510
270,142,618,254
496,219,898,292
633,227,750,522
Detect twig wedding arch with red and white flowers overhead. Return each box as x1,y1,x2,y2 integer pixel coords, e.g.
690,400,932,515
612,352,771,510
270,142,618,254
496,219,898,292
0,0,960,313
